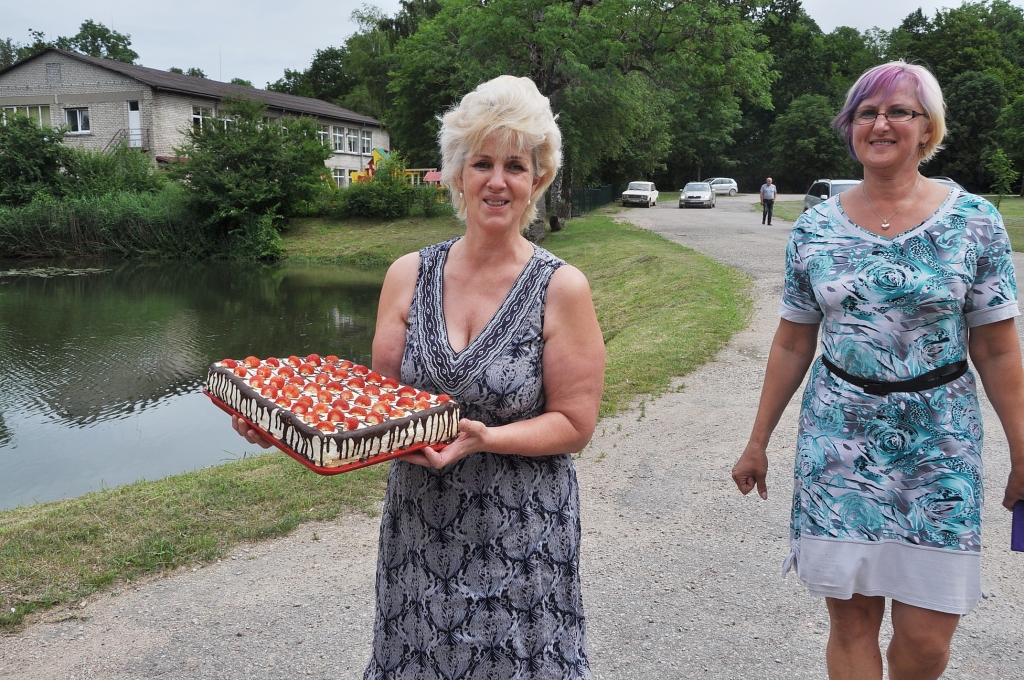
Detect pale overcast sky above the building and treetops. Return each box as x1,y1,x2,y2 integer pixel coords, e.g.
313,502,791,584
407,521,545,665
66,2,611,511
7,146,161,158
6,0,1024,87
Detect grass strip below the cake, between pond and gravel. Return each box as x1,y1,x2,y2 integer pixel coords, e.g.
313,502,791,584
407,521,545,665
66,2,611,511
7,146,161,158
0,453,387,631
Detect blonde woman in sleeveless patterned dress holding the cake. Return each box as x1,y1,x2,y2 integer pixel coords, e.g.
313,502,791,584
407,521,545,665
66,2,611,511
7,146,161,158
365,76,604,680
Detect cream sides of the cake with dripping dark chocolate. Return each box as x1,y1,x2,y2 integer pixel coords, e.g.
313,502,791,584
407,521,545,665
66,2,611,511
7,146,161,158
207,364,460,467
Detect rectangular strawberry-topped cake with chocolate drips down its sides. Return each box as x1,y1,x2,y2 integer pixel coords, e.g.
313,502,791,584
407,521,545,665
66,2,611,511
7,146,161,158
206,354,460,468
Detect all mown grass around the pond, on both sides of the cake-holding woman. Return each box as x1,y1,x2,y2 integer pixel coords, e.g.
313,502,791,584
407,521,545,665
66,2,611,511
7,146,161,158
0,209,750,630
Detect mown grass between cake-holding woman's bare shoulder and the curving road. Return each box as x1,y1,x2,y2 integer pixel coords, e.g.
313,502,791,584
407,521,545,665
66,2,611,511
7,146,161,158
544,214,750,415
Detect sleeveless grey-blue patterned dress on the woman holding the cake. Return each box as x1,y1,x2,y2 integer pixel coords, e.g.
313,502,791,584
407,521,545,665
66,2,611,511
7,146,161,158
364,240,591,680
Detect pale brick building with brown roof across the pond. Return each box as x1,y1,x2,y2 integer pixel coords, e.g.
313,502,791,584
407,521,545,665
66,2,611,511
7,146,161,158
0,48,390,185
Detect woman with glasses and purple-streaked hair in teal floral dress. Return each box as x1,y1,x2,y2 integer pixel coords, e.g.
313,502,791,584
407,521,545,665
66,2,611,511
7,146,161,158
732,61,1024,680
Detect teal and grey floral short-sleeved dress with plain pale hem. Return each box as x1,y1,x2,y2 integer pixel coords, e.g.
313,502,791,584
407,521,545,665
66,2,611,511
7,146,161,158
779,188,1020,614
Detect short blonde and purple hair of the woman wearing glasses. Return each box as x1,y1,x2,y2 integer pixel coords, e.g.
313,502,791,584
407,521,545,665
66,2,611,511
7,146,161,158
833,60,946,163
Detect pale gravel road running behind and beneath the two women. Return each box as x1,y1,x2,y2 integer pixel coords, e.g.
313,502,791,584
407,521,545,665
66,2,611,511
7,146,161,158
0,196,1024,680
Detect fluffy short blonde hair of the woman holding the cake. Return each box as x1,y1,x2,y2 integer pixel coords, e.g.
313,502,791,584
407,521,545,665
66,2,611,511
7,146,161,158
438,76,562,228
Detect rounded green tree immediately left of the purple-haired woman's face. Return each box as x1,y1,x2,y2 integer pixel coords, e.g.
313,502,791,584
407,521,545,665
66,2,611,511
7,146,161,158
765,94,857,188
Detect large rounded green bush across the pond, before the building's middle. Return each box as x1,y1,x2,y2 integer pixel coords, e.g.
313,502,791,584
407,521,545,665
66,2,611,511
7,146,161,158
171,99,331,257
